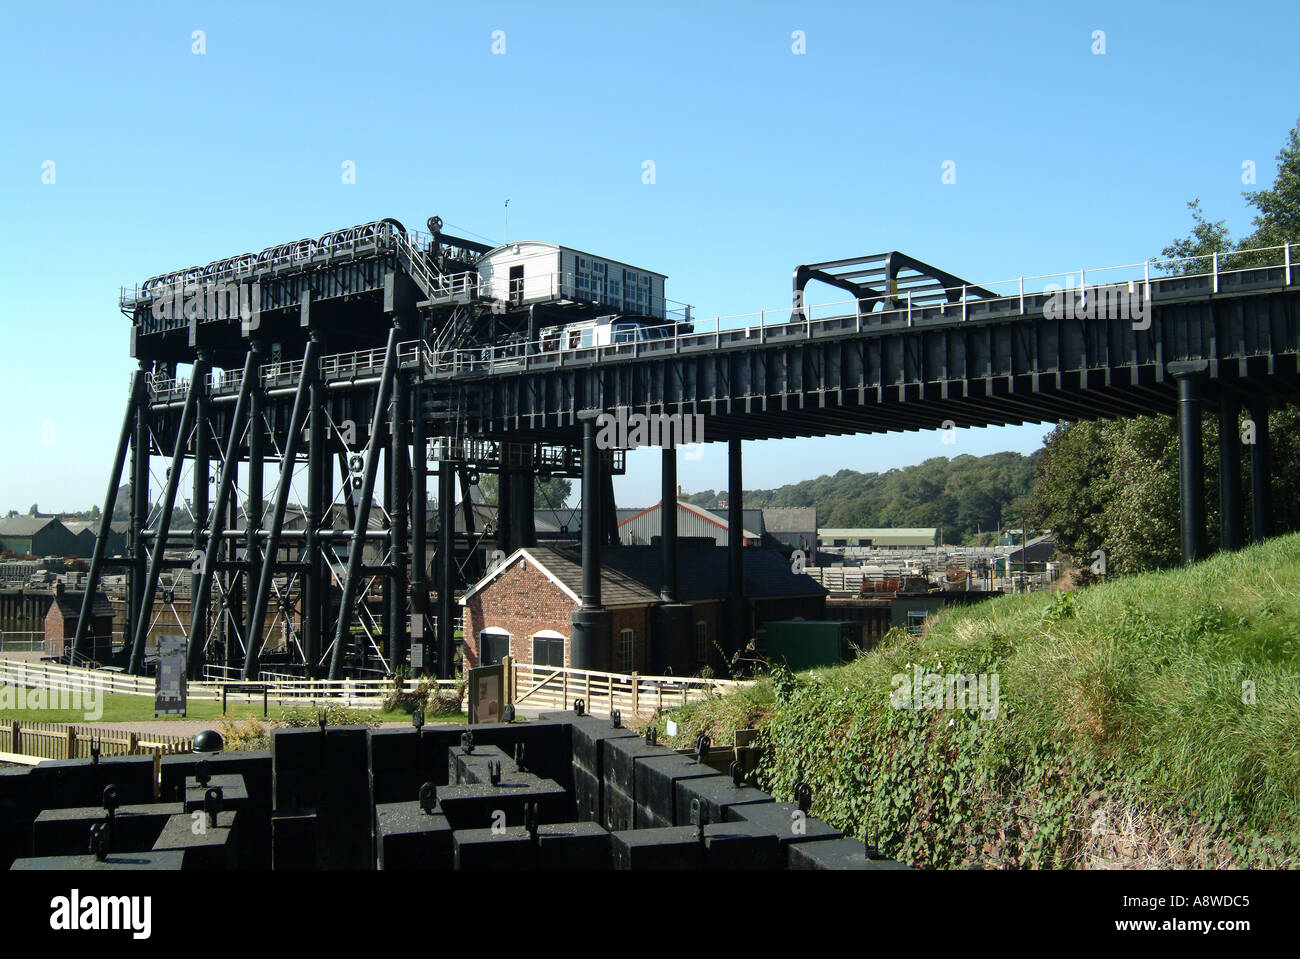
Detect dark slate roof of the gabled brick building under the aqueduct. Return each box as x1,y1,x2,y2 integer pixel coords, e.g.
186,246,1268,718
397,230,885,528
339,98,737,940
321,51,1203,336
465,546,828,606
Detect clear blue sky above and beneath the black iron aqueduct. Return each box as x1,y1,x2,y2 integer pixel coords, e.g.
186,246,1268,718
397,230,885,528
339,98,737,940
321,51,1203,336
0,0,1300,511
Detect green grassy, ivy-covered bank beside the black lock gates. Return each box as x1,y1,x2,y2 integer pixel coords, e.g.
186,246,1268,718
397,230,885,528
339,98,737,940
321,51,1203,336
676,534,1300,868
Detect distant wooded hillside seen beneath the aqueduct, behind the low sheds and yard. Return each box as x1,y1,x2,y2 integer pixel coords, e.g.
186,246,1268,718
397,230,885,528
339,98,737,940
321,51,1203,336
686,452,1041,546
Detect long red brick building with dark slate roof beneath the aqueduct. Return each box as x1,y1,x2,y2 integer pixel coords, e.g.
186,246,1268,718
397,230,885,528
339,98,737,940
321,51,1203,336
462,546,827,676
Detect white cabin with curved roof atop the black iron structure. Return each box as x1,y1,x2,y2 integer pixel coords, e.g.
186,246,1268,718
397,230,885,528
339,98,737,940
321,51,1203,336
478,240,667,320
